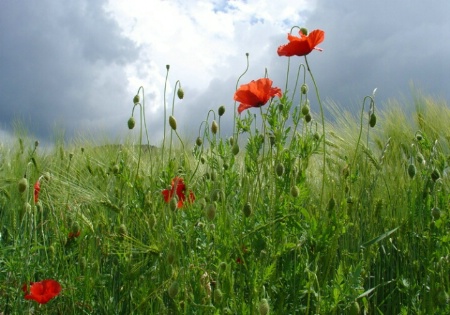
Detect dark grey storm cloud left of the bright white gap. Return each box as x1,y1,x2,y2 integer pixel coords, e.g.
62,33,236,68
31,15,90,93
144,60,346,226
0,0,139,143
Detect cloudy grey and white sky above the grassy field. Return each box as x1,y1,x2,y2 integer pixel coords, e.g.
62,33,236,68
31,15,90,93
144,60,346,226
0,0,450,144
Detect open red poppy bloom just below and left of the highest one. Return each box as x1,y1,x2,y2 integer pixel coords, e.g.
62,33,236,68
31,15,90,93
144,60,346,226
234,78,281,114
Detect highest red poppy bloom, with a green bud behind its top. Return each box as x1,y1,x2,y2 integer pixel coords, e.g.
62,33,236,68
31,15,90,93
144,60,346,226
277,30,325,57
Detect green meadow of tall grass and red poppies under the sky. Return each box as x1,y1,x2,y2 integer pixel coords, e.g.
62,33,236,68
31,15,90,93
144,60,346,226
0,30,450,315
